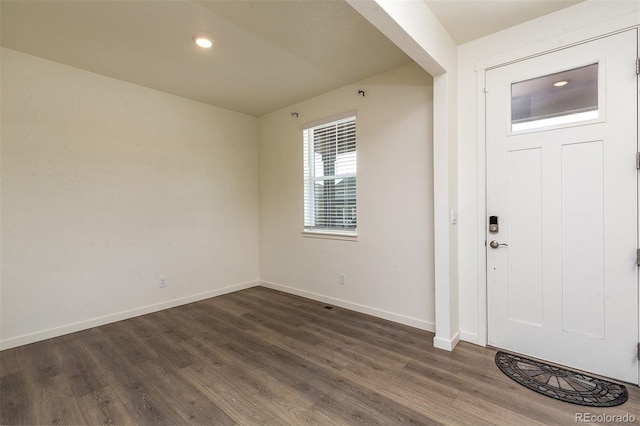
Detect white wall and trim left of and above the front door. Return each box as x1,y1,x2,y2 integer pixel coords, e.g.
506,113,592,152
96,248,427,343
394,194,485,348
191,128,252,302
458,1,640,344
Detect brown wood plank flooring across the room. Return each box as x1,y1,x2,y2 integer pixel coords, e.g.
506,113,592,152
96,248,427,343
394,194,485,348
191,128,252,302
0,287,640,425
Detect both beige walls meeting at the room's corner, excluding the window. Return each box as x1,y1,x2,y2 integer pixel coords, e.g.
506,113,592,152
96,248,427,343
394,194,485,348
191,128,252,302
0,49,434,348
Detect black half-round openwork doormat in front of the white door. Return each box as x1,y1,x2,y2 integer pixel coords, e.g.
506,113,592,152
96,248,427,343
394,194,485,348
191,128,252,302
496,352,629,407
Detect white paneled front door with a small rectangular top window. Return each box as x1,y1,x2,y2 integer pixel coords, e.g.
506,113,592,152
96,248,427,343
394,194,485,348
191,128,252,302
486,30,639,384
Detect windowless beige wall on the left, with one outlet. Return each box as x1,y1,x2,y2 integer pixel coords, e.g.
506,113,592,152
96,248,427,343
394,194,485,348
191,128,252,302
0,49,258,348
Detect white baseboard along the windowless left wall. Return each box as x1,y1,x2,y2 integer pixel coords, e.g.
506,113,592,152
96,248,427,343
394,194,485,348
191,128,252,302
0,281,258,350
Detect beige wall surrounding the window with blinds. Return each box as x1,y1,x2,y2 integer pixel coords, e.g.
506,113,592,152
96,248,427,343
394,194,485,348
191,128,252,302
259,63,434,330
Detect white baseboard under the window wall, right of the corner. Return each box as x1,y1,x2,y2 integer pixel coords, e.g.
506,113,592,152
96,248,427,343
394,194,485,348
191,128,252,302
260,281,435,332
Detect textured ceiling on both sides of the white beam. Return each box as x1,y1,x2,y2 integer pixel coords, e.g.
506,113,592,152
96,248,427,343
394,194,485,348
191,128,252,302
0,0,575,116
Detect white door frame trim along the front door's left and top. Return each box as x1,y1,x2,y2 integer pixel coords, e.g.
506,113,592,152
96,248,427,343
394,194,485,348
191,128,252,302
476,24,640,380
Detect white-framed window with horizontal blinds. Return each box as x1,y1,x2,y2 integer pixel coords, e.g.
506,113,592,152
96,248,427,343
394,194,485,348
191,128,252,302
303,116,356,235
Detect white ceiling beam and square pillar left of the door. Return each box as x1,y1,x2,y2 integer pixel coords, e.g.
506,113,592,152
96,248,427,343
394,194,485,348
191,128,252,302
347,0,460,351
